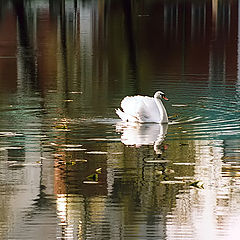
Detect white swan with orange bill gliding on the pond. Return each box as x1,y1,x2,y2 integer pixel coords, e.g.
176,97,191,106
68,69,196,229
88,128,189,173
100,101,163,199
116,91,168,123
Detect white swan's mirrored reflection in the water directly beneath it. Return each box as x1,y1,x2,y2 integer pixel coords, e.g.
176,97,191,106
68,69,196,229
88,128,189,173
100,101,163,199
116,122,168,154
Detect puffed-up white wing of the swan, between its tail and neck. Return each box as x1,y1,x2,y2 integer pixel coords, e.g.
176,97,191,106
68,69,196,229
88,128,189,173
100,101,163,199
121,96,159,122
